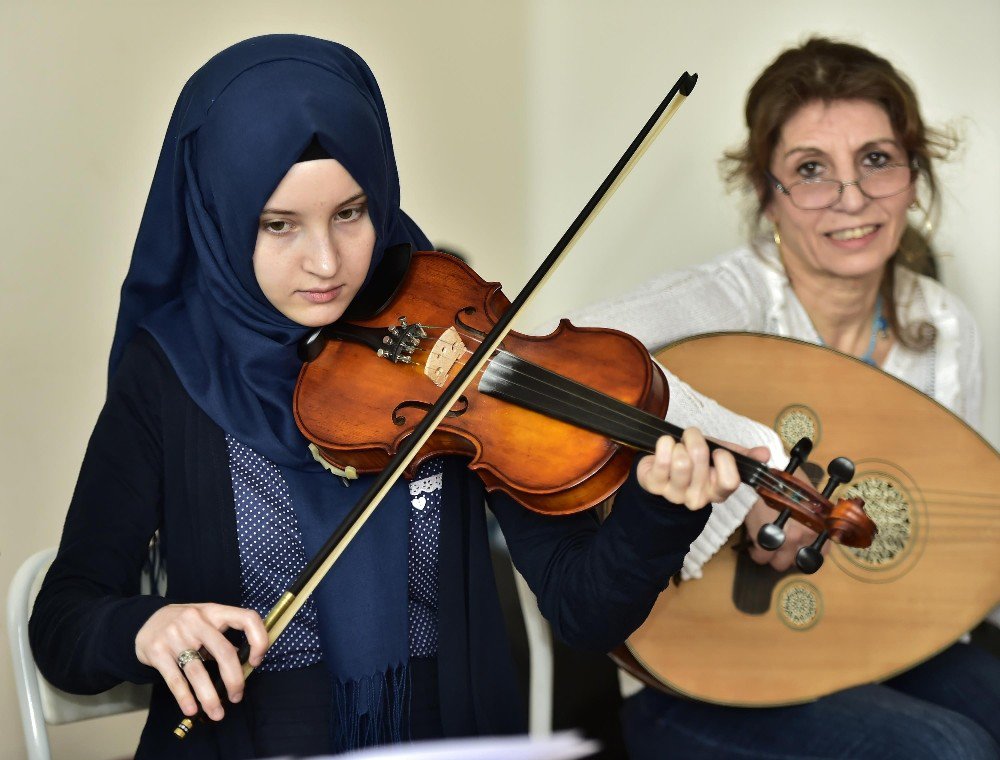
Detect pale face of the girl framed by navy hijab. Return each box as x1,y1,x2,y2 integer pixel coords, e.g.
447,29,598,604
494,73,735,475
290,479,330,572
253,158,375,327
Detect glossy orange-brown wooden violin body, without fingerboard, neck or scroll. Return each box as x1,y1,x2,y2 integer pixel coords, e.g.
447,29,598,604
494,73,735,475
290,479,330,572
294,252,668,514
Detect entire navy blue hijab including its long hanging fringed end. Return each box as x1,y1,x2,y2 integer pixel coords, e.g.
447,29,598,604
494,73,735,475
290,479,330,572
110,35,431,748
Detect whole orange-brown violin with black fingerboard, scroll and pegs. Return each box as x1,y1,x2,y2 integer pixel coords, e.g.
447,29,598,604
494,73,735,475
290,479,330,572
294,252,875,572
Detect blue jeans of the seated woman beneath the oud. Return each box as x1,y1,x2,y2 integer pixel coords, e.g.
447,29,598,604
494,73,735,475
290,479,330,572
622,644,1000,760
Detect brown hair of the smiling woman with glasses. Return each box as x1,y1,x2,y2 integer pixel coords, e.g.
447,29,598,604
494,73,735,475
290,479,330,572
723,37,957,350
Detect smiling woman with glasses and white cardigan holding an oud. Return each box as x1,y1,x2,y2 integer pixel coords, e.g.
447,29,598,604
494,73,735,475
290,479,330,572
571,38,1000,760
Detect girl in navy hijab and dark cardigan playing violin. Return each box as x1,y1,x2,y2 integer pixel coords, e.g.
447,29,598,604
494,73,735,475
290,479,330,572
30,35,756,758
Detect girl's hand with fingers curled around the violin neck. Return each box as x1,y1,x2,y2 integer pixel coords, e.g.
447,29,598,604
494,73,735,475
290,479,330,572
636,428,769,510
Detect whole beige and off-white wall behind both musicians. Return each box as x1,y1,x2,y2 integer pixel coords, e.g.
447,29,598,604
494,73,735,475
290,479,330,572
0,0,1000,758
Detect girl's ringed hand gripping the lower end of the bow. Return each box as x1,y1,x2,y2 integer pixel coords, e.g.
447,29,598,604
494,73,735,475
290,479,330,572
135,603,268,720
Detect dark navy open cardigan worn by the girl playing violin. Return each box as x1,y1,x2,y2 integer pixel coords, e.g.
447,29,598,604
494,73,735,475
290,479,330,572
29,332,708,758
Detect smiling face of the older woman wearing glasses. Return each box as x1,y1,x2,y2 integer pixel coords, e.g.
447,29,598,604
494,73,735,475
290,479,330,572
765,100,915,279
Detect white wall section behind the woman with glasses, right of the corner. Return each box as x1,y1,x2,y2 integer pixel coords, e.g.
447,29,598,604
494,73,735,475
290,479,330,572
526,0,1000,446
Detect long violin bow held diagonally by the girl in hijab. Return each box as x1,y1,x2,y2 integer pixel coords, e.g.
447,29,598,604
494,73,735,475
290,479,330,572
174,71,698,739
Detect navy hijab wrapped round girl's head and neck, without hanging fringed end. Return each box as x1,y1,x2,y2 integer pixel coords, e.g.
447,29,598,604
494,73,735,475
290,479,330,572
110,35,431,468
